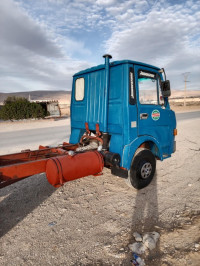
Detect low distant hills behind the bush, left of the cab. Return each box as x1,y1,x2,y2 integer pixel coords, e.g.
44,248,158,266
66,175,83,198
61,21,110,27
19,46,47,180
0,91,71,104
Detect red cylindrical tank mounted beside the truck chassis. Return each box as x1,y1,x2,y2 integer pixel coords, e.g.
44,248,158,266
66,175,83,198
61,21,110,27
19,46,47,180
46,151,104,187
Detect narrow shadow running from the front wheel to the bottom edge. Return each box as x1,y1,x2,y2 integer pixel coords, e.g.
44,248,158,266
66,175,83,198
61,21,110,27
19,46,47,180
125,173,162,266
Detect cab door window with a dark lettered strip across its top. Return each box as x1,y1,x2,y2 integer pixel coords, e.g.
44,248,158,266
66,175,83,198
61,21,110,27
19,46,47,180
138,70,158,105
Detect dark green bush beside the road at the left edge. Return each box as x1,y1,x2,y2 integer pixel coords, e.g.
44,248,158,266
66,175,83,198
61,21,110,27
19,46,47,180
0,97,47,120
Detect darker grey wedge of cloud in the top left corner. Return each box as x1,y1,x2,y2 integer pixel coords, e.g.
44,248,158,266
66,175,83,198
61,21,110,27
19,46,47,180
0,0,61,57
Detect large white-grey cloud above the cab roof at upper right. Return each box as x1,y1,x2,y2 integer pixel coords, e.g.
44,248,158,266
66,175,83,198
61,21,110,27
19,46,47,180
105,1,200,89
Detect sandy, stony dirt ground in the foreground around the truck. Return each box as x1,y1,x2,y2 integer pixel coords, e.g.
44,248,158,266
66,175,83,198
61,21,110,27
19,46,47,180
0,108,200,266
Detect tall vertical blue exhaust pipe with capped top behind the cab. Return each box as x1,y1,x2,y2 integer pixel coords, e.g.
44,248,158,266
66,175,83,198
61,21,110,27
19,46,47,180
102,54,112,133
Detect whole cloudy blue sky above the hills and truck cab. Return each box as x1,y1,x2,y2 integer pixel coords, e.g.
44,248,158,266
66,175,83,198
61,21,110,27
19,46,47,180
0,0,200,92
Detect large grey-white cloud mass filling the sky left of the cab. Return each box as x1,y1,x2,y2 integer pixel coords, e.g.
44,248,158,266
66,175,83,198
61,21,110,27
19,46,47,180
0,0,90,92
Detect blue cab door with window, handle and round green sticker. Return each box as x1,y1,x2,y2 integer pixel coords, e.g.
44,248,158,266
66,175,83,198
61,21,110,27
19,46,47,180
134,65,171,157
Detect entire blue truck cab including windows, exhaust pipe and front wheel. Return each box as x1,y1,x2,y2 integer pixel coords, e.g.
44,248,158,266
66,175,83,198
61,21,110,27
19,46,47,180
70,55,177,189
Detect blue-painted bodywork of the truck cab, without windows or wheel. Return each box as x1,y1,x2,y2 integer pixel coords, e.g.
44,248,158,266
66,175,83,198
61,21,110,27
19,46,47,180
70,60,176,169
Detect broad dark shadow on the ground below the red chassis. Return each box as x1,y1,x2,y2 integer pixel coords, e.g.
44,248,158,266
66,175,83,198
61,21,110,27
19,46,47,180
0,174,56,237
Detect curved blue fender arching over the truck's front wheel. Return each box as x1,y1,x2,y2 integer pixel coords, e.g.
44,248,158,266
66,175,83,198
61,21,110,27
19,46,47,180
122,135,163,170
